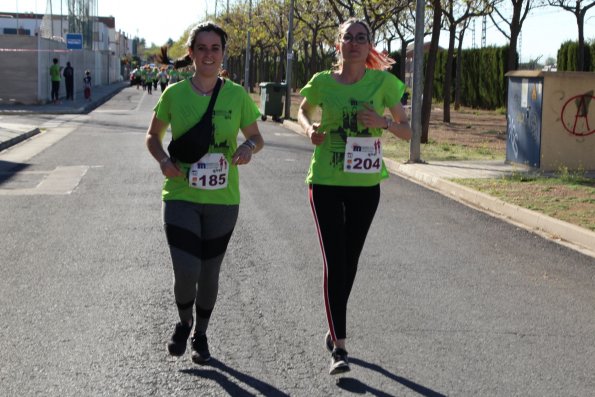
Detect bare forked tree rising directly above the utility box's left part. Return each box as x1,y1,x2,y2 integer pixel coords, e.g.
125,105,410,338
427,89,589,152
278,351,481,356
489,0,545,70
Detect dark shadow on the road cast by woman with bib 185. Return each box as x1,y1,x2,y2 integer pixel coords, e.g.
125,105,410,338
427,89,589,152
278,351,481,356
180,359,289,397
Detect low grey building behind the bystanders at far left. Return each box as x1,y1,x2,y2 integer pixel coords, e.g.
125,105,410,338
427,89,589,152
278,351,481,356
0,12,132,104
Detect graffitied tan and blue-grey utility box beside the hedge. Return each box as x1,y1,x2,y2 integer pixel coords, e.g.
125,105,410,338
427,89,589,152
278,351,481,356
506,70,595,171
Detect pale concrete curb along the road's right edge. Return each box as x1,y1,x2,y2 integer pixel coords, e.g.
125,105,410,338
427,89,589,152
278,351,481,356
283,120,595,258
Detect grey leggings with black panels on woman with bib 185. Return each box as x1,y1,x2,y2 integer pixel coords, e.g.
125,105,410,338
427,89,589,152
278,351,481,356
162,201,239,333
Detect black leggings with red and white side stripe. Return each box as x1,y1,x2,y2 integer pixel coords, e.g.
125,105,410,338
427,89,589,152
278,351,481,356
309,185,380,341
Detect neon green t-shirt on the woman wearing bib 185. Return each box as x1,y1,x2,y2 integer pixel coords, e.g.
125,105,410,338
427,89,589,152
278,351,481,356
154,80,260,205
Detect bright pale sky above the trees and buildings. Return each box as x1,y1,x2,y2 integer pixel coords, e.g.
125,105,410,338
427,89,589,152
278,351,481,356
5,0,595,63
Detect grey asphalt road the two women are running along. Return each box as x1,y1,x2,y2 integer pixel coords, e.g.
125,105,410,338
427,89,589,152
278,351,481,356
0,88,595,396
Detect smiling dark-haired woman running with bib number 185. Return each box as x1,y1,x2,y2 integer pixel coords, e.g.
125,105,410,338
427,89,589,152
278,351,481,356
146,22,264,364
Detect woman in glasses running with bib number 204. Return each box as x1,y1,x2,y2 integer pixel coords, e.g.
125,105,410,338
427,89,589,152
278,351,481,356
298,18,411,375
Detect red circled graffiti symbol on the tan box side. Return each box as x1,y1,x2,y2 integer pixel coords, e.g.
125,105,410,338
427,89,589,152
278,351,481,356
560,91,595,137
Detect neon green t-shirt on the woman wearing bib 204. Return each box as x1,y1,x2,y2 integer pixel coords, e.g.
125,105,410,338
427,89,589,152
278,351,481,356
300,69,405,186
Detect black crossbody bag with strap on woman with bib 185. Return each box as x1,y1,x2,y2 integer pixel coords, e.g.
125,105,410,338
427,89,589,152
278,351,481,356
167,78,221,163
